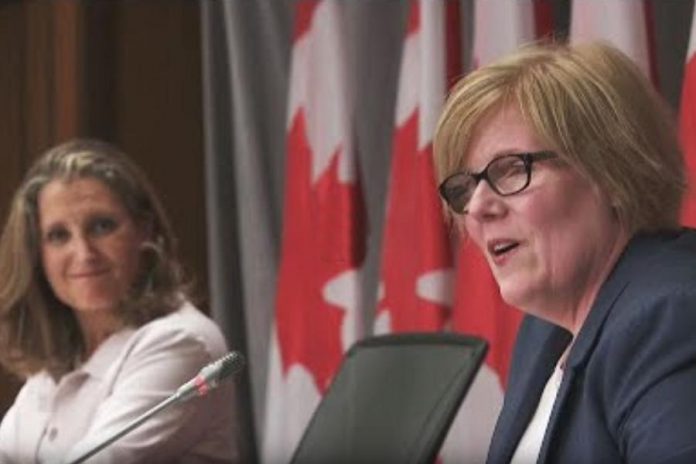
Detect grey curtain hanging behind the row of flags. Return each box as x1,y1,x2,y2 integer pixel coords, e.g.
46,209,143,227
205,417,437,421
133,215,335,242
202,0,693,460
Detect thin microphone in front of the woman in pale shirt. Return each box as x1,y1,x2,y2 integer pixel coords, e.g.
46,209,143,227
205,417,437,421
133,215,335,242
69,351,245,464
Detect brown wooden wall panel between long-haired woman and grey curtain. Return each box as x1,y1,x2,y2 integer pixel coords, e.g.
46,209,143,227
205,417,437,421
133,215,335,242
86,0,207,310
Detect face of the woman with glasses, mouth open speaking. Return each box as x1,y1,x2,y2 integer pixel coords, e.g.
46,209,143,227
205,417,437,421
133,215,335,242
460,106,626,325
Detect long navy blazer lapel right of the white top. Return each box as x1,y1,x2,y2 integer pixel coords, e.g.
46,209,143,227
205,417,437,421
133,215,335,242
537,236,655,464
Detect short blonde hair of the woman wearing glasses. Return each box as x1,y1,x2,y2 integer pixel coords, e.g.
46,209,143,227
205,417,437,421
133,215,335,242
433,42,686,233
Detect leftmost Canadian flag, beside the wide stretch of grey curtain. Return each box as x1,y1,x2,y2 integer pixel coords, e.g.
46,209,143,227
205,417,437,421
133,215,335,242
262,0,365,464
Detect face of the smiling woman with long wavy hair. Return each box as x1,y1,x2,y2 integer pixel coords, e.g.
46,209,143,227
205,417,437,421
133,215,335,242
38,178,147,317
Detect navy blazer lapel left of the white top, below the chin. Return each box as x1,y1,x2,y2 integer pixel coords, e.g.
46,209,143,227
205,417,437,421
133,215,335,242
488,318,570,464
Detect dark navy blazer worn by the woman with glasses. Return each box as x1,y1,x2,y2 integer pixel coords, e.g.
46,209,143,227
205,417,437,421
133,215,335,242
488,230,696,464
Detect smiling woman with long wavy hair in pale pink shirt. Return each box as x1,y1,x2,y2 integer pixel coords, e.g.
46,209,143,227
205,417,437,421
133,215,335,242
0,139,235,463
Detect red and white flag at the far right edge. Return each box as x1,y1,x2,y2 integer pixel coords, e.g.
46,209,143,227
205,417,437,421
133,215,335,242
679,10,696,227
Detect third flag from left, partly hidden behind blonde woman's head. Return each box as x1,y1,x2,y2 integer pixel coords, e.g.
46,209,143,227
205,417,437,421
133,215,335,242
443,0,552,463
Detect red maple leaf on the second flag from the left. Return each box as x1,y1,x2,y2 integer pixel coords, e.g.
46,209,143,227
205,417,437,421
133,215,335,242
378,111,451,332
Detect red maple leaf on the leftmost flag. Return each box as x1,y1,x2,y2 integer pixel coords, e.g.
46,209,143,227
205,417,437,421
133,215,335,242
276,109,365,393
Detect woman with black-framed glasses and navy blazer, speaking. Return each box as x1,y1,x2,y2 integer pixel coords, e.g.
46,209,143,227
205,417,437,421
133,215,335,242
434,42,696,463
